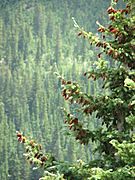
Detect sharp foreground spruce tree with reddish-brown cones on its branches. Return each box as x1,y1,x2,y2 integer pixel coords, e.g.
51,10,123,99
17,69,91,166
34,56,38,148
17,0,135,180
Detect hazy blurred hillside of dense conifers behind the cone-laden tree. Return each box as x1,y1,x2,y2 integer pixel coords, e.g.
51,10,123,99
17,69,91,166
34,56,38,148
0,0,122,180
